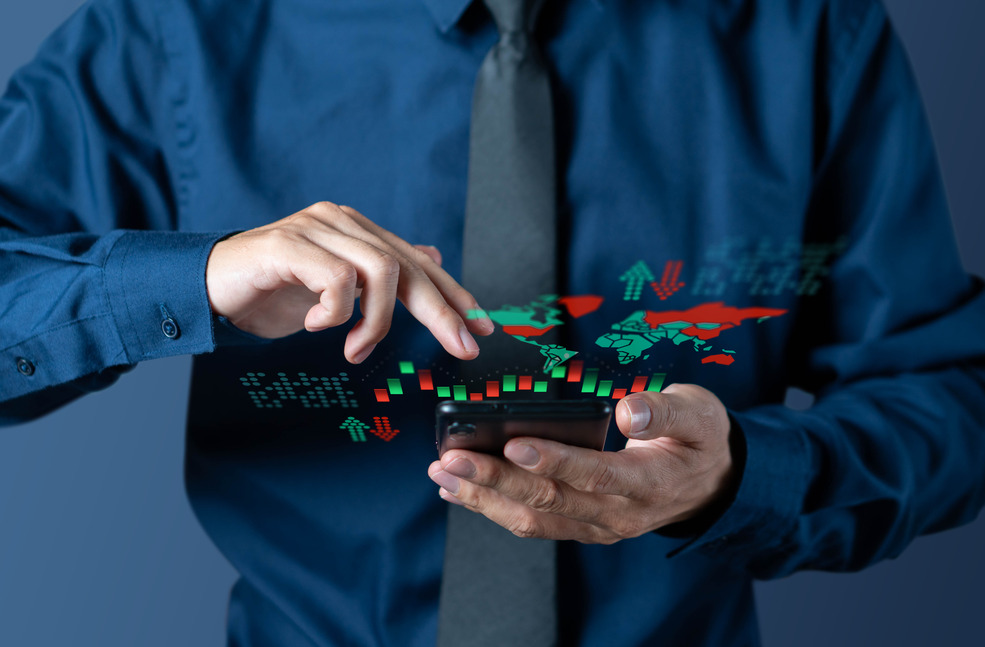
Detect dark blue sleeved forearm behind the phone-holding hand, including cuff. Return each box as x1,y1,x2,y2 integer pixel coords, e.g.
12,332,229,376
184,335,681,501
704,364,985,578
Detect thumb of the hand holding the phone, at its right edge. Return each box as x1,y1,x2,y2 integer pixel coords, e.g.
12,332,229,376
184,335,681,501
616,384,729,444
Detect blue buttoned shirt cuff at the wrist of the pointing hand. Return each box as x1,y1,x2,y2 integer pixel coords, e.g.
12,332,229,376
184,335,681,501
104,231,229,364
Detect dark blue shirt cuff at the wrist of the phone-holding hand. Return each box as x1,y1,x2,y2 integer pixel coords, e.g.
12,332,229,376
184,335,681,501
668,405,813,563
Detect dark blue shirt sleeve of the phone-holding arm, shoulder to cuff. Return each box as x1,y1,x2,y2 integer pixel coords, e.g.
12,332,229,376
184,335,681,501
676,1,985,578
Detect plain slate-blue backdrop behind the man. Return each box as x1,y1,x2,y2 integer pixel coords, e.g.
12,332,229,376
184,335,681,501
0,0,985,647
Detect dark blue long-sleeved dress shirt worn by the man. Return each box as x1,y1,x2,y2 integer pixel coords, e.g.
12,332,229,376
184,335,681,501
0,0,985,647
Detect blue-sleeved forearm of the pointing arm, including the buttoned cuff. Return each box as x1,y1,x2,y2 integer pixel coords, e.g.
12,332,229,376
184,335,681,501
0,228,224,423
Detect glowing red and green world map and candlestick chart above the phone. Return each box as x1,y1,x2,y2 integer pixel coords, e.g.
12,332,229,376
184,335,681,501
229,243,846,443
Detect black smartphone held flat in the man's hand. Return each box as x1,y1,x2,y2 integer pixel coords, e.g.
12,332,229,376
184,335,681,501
435,400,612,456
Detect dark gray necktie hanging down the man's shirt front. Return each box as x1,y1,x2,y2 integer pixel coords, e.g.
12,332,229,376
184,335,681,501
438,0,557,647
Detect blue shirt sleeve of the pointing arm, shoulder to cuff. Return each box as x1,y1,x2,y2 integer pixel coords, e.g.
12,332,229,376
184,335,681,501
0,0,226,423
